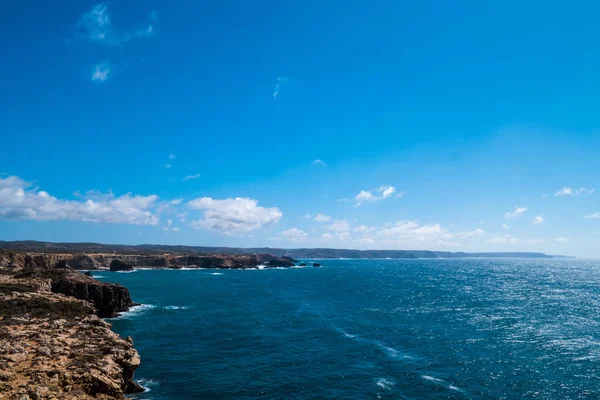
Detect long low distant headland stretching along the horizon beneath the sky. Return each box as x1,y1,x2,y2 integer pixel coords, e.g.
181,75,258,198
0,240,575,259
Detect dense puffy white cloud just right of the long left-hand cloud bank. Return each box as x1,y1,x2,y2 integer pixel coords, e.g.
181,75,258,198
187,197,283,235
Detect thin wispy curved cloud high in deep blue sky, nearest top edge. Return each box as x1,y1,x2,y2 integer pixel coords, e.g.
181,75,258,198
76,3,158,46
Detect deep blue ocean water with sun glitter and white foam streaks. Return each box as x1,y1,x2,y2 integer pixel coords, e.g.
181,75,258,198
95,260,600,400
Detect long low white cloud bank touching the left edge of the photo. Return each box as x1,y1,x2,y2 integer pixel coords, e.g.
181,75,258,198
0,176,159,225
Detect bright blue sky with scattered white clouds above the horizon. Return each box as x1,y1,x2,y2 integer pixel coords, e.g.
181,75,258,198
0,0,600,258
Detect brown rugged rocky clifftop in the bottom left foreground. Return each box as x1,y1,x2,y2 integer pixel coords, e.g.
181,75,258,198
0,271,143,399
